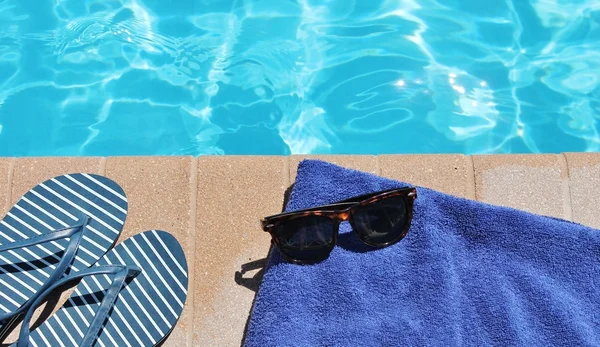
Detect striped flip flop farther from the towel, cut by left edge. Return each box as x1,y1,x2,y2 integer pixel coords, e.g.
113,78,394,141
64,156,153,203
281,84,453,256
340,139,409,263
0,173,127,339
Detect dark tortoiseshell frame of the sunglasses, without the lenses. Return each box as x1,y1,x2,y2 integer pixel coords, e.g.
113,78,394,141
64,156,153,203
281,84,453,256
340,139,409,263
261,187,417,263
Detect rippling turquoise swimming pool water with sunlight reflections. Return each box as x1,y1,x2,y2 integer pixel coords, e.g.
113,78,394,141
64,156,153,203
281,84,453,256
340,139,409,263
0,0,600,156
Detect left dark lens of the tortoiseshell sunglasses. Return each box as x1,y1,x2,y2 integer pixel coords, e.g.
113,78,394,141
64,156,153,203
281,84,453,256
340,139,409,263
274,216,336,262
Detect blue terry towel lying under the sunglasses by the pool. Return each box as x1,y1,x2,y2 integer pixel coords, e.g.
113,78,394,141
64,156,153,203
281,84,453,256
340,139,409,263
244,160,600,347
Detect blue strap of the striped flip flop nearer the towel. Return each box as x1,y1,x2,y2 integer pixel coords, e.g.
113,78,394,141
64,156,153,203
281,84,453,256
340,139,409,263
17,265,142,347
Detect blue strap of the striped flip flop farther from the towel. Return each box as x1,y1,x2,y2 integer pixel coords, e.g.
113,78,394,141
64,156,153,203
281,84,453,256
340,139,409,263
0,216,90,322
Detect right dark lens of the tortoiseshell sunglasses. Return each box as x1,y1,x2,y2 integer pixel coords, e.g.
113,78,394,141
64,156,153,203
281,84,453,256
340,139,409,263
353,196,408,246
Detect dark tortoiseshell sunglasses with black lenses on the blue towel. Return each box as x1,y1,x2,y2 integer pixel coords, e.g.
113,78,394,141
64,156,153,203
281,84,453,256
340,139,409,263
261,187,417,263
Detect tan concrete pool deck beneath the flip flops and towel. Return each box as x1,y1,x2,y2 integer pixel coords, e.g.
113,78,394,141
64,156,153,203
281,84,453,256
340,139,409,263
0,153,600,347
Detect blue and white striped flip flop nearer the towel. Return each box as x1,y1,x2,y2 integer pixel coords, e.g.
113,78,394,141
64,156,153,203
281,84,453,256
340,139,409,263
14,230,188,347
